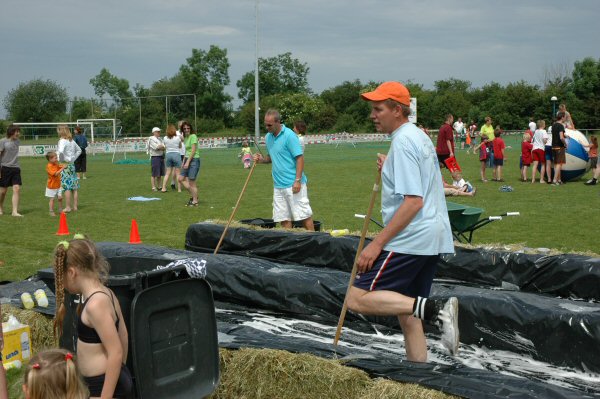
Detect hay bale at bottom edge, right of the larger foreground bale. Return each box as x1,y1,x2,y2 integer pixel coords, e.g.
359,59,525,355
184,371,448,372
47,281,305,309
360,378,459,399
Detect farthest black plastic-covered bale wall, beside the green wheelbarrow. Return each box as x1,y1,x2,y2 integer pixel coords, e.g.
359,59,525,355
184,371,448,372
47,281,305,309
185,223,600,301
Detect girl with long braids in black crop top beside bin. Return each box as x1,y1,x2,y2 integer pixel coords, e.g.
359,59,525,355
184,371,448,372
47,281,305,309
54,238,133,399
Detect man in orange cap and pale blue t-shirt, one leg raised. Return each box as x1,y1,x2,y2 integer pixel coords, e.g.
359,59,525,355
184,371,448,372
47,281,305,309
348,82,458,362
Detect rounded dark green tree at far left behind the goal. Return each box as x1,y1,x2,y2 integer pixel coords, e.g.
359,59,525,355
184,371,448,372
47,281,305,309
4,79,69,122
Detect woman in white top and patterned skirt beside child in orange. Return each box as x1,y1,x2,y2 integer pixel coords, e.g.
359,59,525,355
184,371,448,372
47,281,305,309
56,125,81,212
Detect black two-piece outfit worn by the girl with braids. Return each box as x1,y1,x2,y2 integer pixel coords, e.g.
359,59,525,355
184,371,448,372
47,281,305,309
77,291,133,399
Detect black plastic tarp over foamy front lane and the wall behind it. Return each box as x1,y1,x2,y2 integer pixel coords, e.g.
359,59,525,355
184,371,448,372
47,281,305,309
0,243,600,398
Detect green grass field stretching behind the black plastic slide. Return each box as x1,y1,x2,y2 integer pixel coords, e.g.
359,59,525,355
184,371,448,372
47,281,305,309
0,142,600,280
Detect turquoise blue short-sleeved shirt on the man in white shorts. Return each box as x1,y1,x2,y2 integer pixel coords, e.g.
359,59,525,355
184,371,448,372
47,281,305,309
265,124,307,188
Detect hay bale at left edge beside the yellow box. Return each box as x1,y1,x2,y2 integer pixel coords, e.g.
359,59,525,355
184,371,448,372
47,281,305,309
2,305,58,354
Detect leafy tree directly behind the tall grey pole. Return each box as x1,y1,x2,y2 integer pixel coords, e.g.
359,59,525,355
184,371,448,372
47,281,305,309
236,52,310,103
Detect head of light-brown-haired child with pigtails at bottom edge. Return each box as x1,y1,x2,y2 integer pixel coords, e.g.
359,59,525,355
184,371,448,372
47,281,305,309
23,349,89,399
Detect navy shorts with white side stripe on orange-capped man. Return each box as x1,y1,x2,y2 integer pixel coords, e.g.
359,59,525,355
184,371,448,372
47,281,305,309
354,251,440,298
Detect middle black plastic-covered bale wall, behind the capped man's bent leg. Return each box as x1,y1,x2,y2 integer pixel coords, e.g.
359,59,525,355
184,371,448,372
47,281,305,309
78,244,600,373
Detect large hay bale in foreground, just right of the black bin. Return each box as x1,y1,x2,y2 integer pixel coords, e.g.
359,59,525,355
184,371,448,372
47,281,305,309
212,349,371,399
